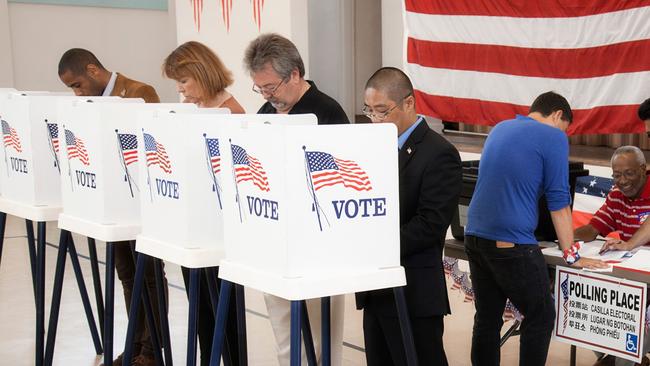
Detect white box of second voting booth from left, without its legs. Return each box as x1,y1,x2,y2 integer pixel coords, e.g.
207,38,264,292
59,98,196,241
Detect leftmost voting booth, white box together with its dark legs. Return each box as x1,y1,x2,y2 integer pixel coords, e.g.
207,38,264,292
0,92,117,365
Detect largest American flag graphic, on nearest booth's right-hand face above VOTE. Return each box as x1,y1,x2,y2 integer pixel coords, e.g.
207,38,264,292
305,151,372,191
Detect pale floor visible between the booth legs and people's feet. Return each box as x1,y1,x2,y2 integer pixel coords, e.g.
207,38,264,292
0,213,595,366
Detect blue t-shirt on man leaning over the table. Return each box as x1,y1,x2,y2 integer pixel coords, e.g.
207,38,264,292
465,115,571,244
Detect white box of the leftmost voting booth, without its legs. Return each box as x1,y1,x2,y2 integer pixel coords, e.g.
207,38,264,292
0,92,106,221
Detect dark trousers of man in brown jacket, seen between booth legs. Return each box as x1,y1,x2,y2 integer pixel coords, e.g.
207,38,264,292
112,241,169,357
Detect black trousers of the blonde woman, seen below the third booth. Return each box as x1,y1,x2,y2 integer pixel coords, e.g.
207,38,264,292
181,267,240,366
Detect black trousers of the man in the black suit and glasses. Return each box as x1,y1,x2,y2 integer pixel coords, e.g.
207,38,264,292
363,310,447,366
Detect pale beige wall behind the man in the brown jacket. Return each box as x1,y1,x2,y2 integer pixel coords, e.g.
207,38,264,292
5,0,180,101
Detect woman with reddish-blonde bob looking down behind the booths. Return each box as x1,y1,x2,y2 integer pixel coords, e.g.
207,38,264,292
163,41,245,113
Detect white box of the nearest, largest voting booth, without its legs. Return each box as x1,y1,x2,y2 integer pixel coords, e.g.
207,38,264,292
219,124,405,300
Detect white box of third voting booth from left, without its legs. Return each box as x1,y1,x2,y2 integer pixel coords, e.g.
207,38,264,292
137,110,316,268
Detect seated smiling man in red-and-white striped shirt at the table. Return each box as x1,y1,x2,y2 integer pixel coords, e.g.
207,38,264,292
574,146,650,366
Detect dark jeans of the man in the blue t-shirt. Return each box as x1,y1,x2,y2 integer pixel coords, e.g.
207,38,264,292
465,235,555,366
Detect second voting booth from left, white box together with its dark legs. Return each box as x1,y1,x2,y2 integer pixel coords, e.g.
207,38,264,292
45,98,202,365
